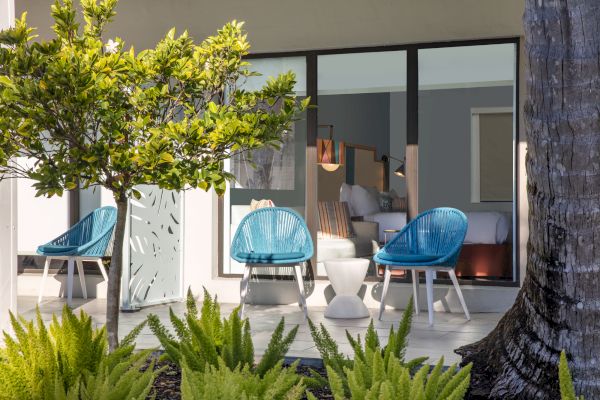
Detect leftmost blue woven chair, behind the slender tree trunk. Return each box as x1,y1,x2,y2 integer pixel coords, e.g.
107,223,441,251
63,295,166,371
37,207,117,304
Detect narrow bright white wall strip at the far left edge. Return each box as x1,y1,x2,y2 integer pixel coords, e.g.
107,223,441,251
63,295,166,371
0,0,17,329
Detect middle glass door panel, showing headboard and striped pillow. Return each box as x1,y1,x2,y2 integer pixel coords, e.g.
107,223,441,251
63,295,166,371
316,51,406,277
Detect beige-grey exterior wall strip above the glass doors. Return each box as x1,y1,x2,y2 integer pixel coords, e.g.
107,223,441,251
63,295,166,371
15,0,524,52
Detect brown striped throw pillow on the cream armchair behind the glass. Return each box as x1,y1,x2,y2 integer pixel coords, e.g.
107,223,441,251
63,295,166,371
317,201,355,239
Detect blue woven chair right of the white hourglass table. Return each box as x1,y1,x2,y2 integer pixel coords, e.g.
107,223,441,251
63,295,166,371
373,208,471,325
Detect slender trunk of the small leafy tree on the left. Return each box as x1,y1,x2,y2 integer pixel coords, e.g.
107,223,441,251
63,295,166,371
106,197,127,351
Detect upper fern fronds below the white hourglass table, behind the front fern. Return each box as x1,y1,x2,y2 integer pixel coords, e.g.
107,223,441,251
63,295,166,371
308,298,427,395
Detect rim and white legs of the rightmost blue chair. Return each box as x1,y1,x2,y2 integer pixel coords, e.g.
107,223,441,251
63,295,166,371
373,208,471,325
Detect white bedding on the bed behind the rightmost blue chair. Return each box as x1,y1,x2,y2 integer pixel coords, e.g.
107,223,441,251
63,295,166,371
363,211,511,244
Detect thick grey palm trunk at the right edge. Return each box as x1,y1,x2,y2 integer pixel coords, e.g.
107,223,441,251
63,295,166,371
456,0,600,399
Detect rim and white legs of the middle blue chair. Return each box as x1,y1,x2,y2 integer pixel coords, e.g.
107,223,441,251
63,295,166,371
231,207,314,320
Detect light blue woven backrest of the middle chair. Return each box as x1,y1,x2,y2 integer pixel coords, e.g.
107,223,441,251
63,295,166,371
231,207,313,258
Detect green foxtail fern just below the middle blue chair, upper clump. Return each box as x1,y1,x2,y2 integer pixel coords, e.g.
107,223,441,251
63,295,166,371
148,289,298,377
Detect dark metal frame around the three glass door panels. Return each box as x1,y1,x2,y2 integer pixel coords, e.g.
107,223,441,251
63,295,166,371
217,37,521,287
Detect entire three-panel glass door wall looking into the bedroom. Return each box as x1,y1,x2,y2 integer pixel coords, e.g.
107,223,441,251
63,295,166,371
220,39,519,285
